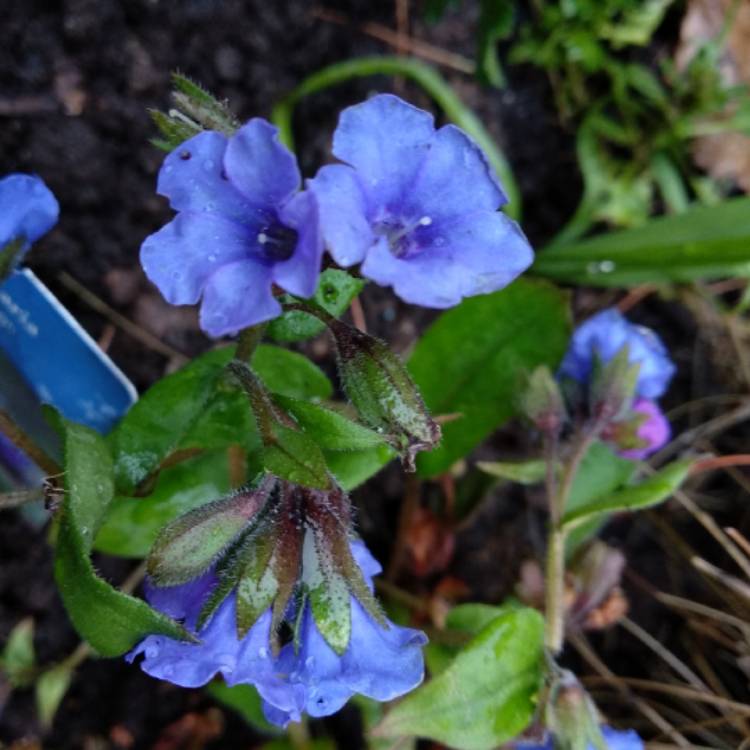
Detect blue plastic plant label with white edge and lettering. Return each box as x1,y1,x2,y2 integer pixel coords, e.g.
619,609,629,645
0,268,137,432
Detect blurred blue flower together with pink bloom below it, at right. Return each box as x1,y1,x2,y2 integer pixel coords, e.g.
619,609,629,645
558,309,675,459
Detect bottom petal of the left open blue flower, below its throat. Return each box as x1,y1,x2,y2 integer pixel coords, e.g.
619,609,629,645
200,259,281,338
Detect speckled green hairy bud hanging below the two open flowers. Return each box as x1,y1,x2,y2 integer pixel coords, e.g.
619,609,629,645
326,319,440,471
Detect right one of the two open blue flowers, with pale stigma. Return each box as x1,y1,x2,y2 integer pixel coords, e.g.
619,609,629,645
309,94,533,308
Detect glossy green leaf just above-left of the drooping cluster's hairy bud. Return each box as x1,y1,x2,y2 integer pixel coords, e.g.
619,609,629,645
94,451,230,558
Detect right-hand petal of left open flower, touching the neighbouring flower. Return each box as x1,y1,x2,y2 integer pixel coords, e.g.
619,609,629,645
273,193,323,297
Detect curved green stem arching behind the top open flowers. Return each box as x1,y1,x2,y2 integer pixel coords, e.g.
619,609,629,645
271,55,521,220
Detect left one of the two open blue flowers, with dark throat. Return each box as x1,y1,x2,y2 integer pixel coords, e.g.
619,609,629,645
141,118,323,337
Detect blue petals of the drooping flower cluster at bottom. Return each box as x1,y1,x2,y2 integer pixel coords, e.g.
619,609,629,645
127,542,427,726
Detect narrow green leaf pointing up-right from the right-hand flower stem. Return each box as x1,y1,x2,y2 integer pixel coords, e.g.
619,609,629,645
562,459,693,529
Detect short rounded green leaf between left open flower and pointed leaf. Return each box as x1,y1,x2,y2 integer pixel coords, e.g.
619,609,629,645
252,344,333,400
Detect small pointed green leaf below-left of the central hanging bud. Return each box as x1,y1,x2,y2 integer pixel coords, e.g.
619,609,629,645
274,396,385,451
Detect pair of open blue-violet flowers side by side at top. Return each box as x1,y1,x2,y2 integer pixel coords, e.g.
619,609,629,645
141,94,533,337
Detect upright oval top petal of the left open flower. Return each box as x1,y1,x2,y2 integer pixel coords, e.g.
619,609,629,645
224,117,301,207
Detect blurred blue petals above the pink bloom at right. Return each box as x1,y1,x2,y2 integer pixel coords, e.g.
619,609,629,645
558,308,675,399
